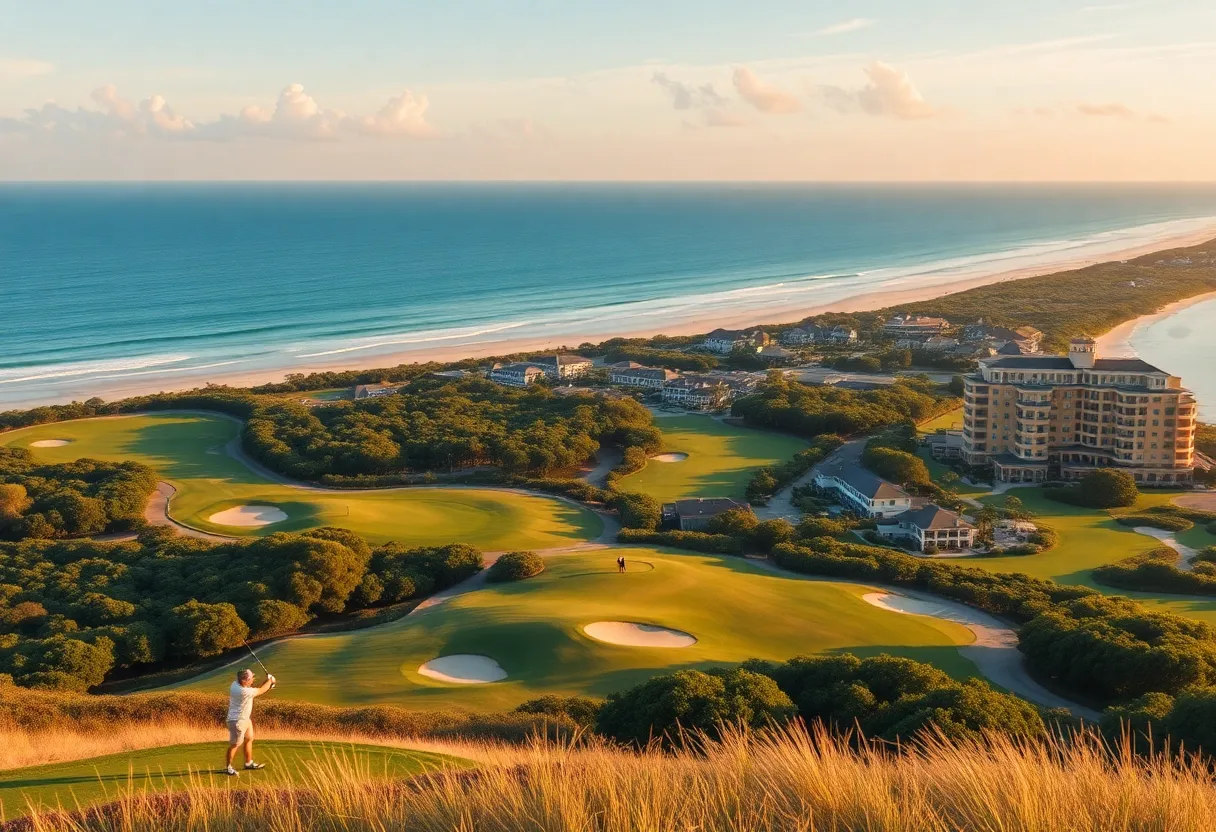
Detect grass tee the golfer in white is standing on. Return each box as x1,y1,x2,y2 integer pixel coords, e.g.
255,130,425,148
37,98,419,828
0,737,459,820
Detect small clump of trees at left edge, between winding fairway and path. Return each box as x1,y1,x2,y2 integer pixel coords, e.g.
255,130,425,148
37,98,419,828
0,448,157,540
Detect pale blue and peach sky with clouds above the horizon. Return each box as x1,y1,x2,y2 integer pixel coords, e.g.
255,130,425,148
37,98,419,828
0,0,1216,180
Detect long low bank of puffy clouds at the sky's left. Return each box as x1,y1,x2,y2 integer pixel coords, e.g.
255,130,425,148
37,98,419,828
0,84,433,141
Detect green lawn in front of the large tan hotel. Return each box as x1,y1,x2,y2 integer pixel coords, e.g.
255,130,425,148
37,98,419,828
961,488,1216,624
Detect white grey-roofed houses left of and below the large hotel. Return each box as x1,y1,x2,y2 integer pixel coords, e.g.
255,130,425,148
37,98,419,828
815,461,975,552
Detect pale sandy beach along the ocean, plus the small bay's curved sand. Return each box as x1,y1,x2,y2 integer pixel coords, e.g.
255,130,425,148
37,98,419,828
9,223,1216,406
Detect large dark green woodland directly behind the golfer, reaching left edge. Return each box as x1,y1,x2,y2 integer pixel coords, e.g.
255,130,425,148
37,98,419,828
0,528,482,691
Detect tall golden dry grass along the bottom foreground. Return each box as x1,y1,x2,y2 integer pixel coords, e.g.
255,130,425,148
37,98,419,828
14,729,1216,832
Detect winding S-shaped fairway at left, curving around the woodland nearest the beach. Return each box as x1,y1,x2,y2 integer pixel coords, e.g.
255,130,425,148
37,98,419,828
0,412,603,551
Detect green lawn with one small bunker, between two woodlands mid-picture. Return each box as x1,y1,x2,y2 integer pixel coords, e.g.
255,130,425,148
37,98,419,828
620,416,806,502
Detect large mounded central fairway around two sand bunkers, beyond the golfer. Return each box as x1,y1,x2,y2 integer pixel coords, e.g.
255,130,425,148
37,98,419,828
175,549,975,710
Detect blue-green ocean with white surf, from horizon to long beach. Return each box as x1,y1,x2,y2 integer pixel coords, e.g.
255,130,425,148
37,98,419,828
0,184,1216,406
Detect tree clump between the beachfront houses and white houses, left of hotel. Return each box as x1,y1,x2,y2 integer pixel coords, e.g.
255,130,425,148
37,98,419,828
731,373,958,437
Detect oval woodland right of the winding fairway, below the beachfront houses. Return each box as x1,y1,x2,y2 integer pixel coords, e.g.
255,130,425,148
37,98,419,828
244,378,662,479
